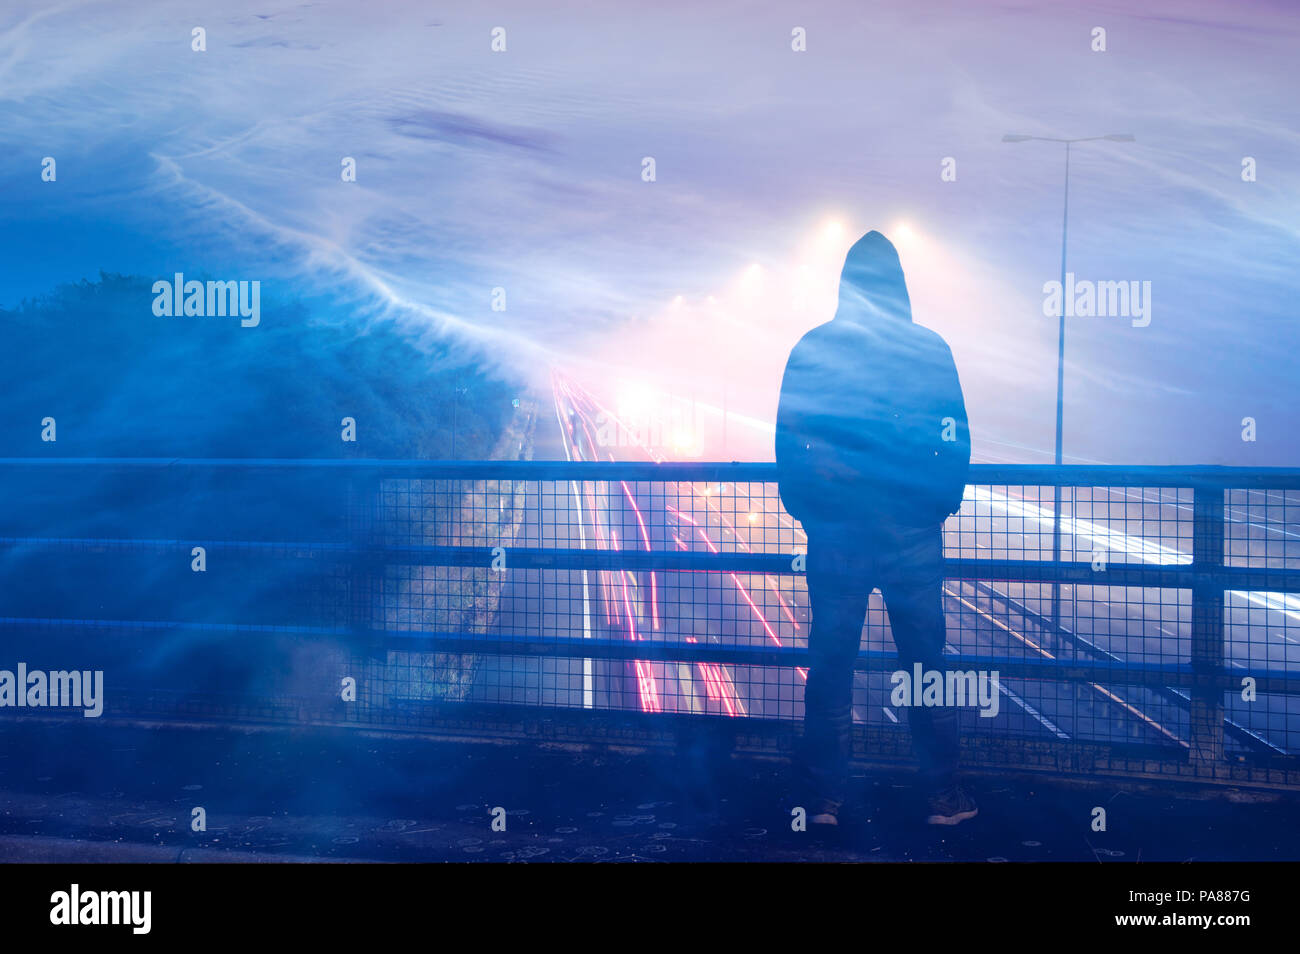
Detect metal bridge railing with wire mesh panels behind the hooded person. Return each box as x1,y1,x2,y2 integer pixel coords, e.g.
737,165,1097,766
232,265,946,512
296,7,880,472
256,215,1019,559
0,458,1300,788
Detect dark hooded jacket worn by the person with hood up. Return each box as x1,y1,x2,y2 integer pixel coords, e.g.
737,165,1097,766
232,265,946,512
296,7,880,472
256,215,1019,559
776,231,970,535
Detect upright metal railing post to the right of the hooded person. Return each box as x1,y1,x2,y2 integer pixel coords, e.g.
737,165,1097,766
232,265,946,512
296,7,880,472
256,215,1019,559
1190,485,1225,776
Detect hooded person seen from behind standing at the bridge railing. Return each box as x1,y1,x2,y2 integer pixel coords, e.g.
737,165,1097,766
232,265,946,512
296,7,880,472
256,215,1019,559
776,231,976,825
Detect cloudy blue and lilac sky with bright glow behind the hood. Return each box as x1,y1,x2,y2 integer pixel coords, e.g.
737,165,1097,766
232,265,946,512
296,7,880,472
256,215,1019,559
0,0,1300,464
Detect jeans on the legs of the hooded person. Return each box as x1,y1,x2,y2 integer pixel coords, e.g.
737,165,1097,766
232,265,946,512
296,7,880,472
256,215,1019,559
802,526,958,811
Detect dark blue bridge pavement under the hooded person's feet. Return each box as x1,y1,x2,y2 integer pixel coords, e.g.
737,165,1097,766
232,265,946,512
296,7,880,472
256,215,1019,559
0,719,1300,863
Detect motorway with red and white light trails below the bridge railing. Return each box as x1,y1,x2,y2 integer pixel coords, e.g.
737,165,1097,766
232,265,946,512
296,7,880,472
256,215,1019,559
473,376,1300,753
